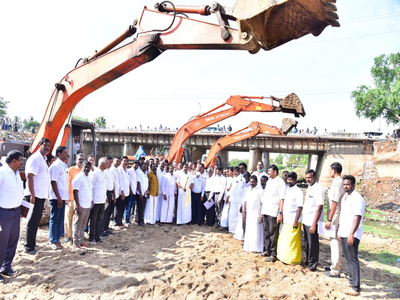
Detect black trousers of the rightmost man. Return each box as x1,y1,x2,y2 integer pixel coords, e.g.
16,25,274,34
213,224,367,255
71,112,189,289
341,237,361,292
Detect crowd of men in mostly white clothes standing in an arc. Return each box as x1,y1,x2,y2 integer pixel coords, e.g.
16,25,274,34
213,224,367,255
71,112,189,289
0,138,365,295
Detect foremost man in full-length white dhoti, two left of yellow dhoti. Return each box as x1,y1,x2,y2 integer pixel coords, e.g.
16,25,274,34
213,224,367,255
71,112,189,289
243,175,264,252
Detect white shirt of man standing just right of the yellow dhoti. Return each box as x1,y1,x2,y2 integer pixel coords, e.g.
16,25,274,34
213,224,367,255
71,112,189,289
303,182,325,226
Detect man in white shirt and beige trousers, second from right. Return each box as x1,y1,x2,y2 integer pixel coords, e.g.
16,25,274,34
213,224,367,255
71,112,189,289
324,162,345,277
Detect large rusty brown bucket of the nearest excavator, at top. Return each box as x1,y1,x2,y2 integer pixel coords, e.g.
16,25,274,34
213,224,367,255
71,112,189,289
232,0,340,50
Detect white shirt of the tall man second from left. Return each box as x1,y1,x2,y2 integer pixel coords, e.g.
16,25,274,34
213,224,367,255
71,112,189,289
25,150,50,199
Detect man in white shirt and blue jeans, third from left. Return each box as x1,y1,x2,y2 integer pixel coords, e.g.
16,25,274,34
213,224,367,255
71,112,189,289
49,146,69,250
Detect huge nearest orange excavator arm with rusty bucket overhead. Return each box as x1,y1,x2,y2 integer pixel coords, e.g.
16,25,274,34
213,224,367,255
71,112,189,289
30,0,340,152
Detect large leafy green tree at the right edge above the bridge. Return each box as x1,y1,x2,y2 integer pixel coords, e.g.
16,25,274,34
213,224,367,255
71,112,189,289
351,53,400,125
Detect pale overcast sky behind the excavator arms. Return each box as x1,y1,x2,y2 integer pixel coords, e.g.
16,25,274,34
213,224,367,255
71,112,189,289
0,0,400,152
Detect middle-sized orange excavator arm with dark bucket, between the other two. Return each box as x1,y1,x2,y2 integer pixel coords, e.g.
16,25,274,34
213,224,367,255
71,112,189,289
166,93,306,163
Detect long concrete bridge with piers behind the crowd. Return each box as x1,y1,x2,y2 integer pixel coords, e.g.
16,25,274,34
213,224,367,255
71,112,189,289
83,130,374,186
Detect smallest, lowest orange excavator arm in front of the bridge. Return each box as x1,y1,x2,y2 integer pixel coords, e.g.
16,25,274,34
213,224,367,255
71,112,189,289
204,118,297,169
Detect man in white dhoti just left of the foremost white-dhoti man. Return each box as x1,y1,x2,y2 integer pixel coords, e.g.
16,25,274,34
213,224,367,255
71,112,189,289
227,167,246,233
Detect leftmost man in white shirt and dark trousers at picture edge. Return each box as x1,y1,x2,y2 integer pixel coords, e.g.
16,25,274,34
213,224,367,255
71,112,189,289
0,150,24,283
